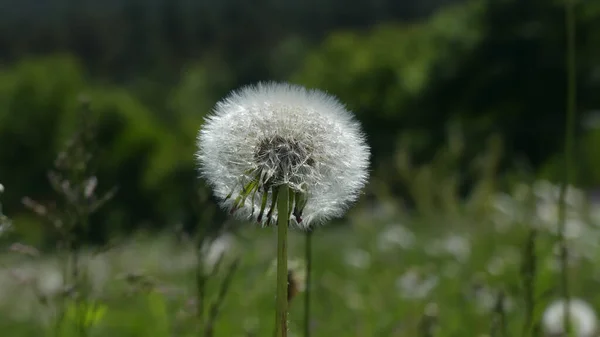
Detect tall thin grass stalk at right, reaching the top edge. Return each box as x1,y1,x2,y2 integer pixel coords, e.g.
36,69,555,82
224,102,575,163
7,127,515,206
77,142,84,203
558,0,577,335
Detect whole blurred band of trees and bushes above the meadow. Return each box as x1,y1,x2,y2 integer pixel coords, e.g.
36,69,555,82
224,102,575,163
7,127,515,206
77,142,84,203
0,0,600,243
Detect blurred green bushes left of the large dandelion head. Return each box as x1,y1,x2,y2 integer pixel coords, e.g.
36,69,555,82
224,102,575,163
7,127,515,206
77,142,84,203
0,56,223,243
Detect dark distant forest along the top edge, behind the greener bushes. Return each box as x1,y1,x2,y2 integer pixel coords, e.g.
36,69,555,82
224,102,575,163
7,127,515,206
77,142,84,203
0,0,462,83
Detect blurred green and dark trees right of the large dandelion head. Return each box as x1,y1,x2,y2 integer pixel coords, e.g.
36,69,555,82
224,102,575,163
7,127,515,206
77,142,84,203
293,0,600,189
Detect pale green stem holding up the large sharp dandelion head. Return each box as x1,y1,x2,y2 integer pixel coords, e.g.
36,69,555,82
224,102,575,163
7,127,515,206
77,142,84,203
273,185,289,337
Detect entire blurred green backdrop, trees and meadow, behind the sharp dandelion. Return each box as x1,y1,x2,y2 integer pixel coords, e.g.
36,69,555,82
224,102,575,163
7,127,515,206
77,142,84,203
0,0,600,337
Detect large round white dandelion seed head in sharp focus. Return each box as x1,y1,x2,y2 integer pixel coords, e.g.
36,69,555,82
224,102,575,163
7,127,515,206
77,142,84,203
197,83,369,228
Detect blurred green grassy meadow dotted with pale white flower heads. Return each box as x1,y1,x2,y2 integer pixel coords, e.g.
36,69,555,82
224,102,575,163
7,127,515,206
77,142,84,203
0,182,600,337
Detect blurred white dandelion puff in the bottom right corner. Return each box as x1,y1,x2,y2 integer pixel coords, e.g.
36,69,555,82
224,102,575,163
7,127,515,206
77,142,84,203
542,299,597,337
